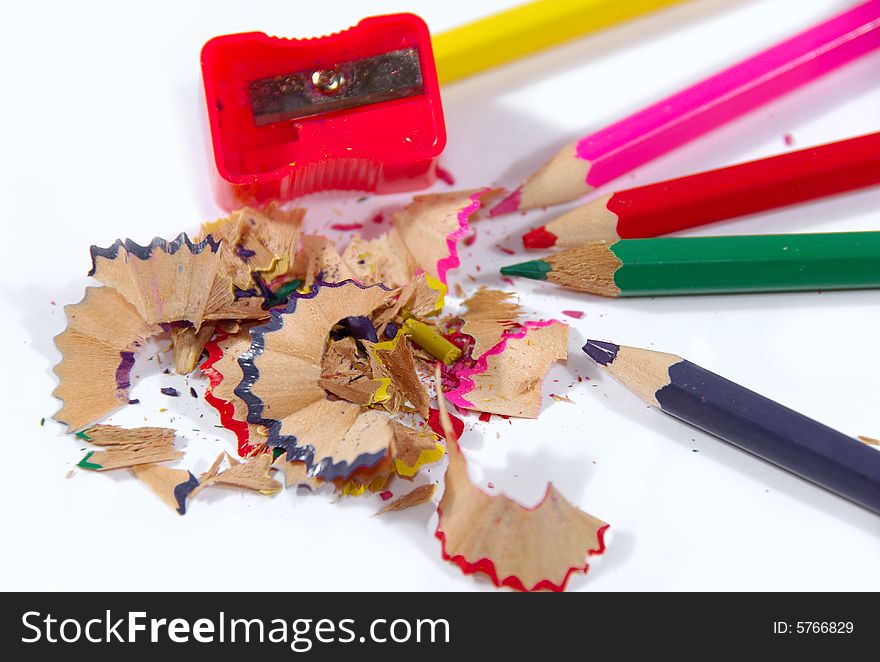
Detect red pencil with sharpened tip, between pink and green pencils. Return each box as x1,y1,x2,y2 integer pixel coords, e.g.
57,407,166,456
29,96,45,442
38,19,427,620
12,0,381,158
523,133,880,248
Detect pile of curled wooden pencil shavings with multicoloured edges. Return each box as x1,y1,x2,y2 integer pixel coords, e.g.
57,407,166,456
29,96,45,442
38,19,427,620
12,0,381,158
54,189,607,590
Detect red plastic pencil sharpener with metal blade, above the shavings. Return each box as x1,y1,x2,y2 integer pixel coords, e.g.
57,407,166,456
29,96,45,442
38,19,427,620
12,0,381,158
202,14,446,209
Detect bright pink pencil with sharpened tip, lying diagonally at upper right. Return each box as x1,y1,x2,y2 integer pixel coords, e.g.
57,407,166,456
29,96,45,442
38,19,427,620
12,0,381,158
492,0,880,216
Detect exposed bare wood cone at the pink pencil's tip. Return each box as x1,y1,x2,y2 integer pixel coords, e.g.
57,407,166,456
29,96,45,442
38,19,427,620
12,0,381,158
519,142,591,210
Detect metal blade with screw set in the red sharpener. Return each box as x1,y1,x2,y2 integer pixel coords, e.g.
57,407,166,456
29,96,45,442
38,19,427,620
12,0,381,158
248,47,424,126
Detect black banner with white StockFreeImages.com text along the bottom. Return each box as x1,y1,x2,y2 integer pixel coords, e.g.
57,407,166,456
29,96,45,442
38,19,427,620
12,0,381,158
0,592,880,660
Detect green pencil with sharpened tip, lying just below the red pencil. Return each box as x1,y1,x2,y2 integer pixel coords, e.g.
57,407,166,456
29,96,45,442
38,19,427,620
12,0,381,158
501,232,880,297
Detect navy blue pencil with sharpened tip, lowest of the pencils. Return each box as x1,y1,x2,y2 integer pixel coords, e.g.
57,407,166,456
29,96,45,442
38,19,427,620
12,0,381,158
584,340,880,514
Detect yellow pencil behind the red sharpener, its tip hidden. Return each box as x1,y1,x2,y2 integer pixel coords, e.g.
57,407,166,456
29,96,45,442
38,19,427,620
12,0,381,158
432,0,681,83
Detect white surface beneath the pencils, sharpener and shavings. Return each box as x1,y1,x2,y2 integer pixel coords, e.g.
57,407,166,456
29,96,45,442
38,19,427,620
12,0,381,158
0,0,880,591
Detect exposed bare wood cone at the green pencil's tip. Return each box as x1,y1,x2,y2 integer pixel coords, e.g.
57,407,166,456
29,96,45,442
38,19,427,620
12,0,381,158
544,241,623,297
